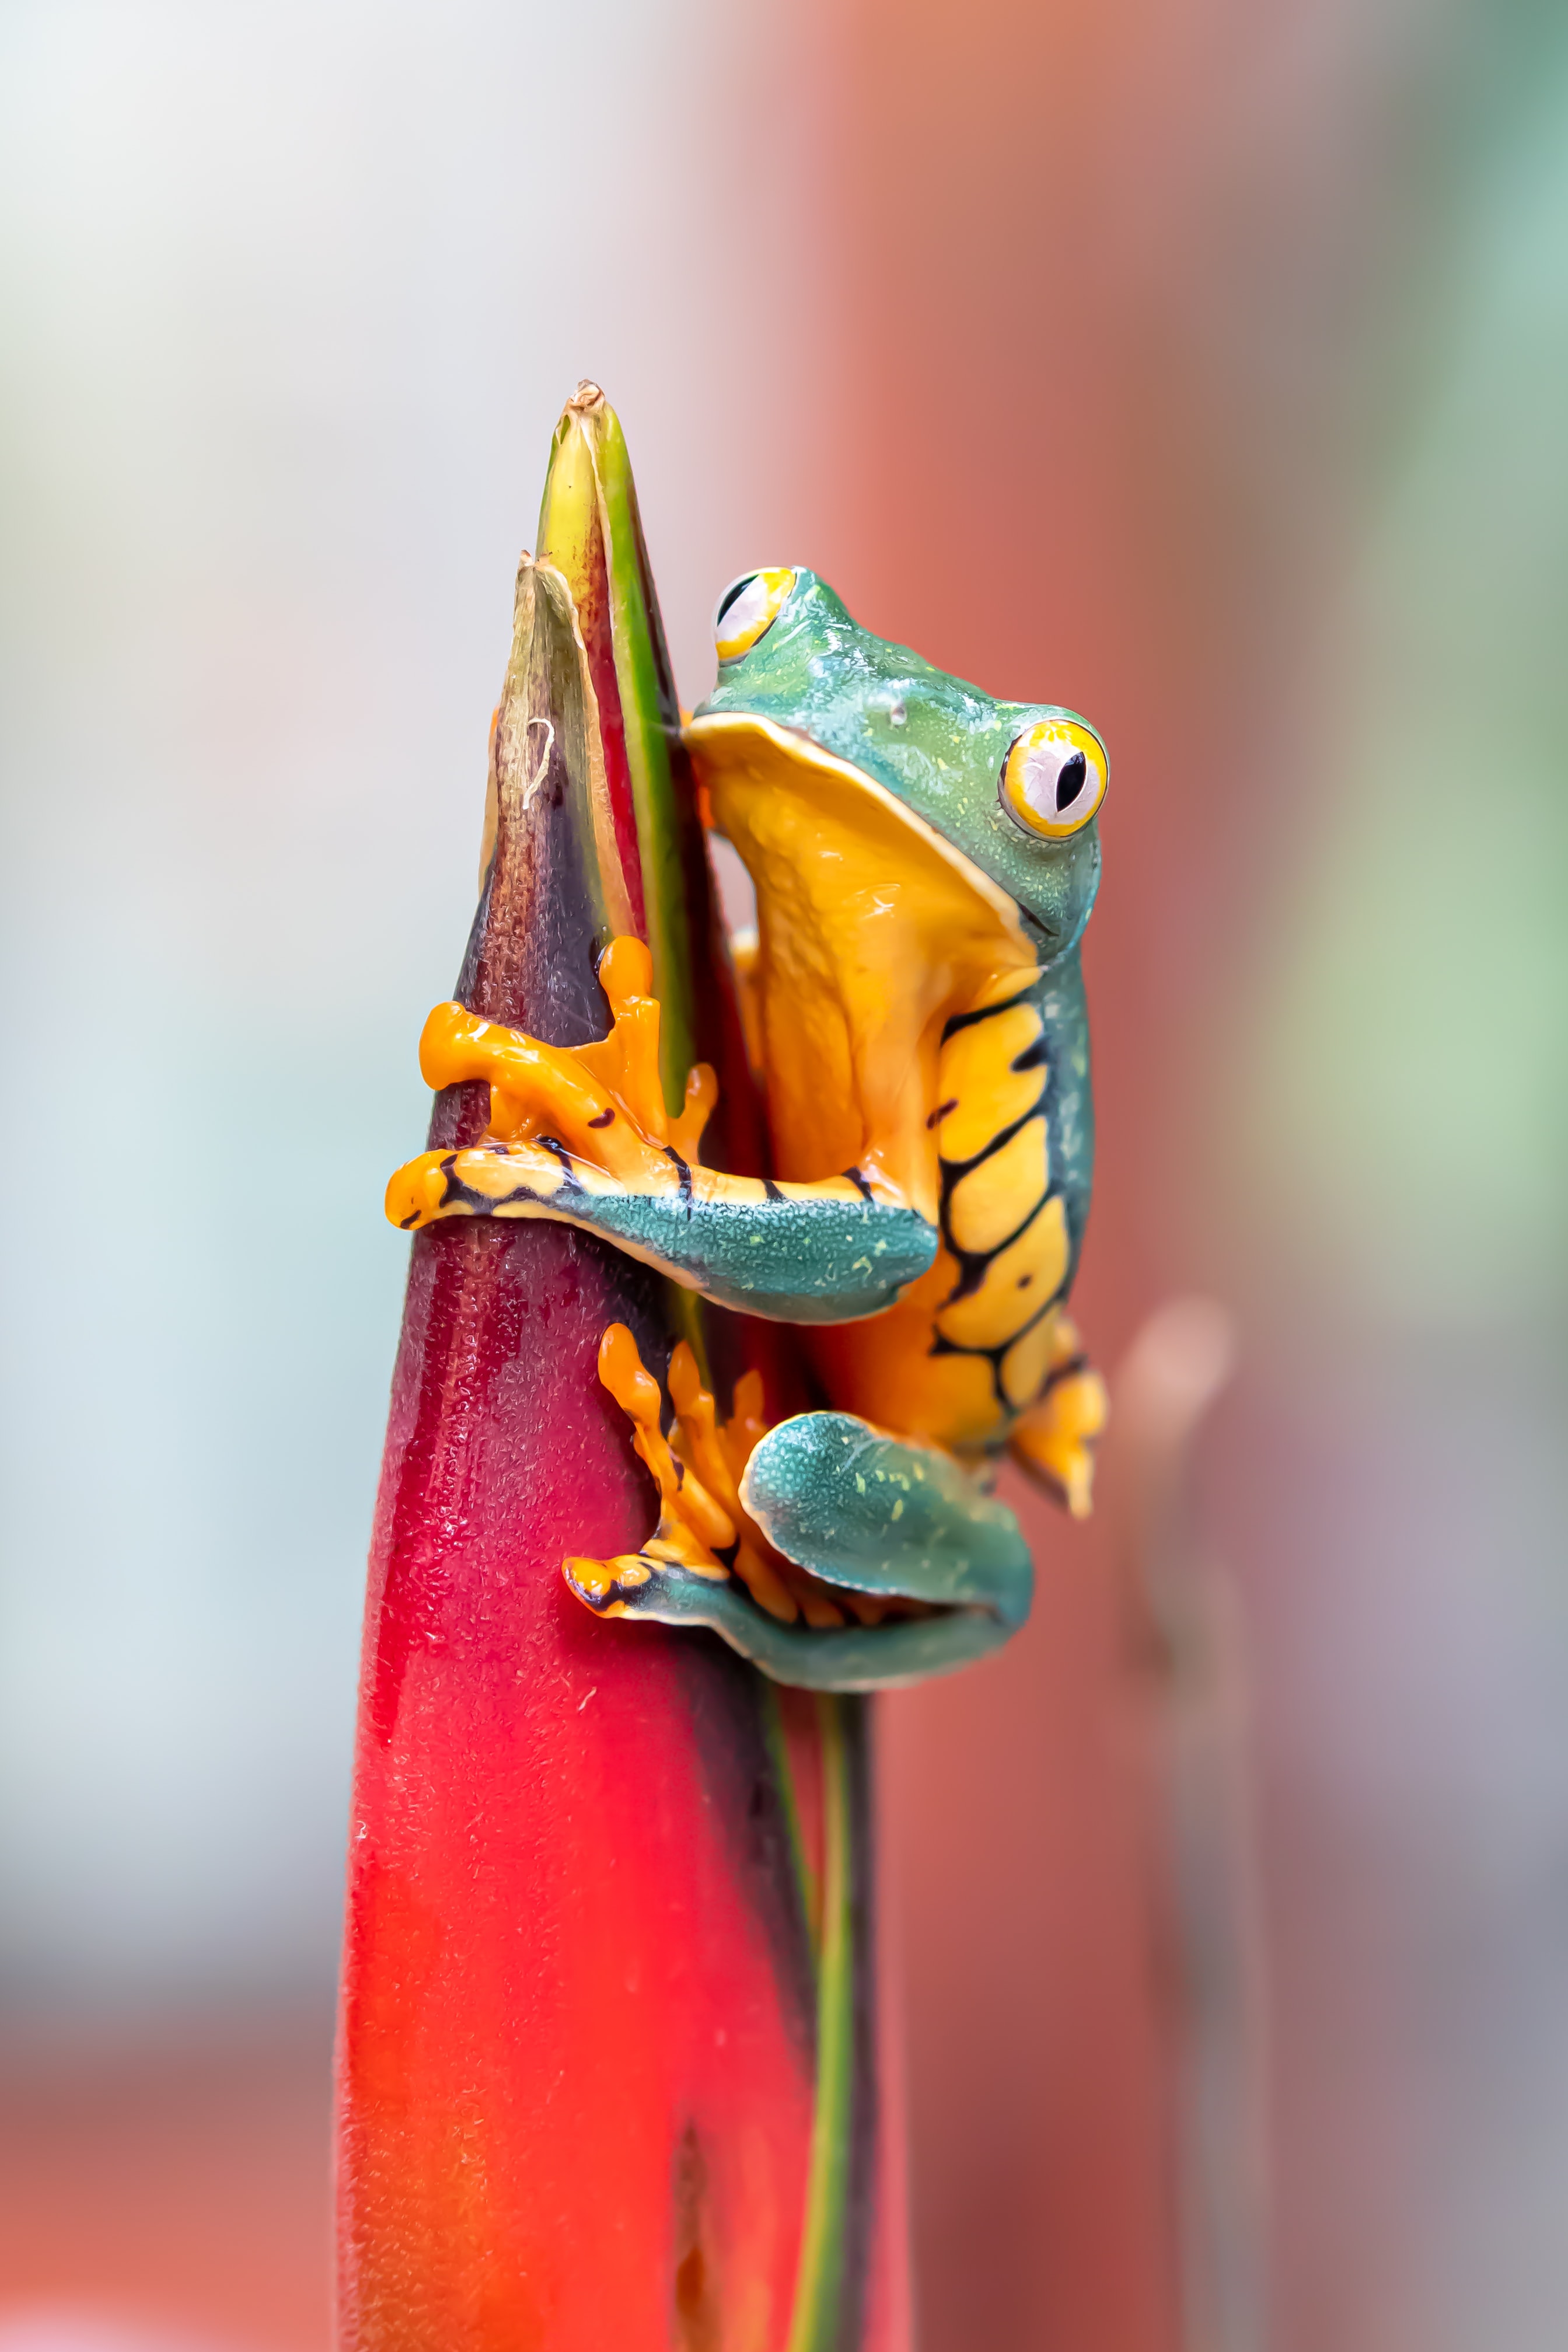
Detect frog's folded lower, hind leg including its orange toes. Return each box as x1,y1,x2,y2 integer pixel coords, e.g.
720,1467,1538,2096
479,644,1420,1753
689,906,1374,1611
564,1324,1035,1691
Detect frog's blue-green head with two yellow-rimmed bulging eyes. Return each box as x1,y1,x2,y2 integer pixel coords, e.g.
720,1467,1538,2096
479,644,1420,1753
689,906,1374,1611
686,567,1105,962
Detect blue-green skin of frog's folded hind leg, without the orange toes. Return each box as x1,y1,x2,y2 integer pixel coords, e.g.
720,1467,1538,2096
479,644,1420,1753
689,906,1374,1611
567,1414,1035,1691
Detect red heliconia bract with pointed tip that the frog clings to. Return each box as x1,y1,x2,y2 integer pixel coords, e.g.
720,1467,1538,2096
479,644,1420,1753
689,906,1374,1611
338,395,907,2352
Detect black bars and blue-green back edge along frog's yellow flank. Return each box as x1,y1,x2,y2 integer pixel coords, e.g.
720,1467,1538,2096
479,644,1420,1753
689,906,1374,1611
928,955,1093,1423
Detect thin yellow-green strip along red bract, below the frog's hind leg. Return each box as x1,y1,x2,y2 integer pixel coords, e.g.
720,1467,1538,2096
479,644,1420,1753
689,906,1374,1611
788,1694,855,2352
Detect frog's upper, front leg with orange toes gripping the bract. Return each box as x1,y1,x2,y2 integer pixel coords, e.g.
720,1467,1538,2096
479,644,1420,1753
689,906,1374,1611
386,938,938,1322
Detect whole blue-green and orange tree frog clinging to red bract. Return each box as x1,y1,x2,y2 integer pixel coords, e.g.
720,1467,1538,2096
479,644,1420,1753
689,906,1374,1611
388,567,1107,1691
